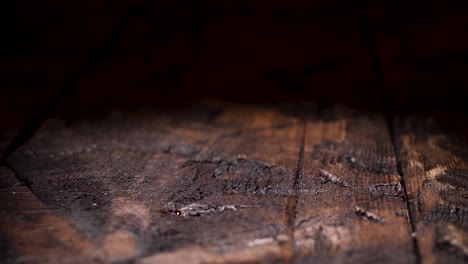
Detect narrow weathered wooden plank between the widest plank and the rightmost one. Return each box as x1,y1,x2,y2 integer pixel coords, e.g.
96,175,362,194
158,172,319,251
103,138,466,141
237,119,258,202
294,108,415,263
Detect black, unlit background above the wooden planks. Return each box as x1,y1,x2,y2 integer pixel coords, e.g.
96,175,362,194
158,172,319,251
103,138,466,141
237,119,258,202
0,0,468,134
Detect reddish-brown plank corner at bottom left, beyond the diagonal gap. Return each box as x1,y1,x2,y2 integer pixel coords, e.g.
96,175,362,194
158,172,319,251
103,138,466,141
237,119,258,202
0,167,94,263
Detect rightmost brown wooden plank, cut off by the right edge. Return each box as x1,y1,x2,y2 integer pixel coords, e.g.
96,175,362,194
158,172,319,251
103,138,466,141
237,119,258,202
396,117,468,263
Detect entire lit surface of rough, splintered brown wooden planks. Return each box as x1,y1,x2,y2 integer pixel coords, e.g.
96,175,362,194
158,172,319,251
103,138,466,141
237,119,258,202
0,103,467,263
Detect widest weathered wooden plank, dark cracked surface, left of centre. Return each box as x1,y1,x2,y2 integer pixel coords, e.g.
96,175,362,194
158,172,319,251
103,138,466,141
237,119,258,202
9,105,303,263
